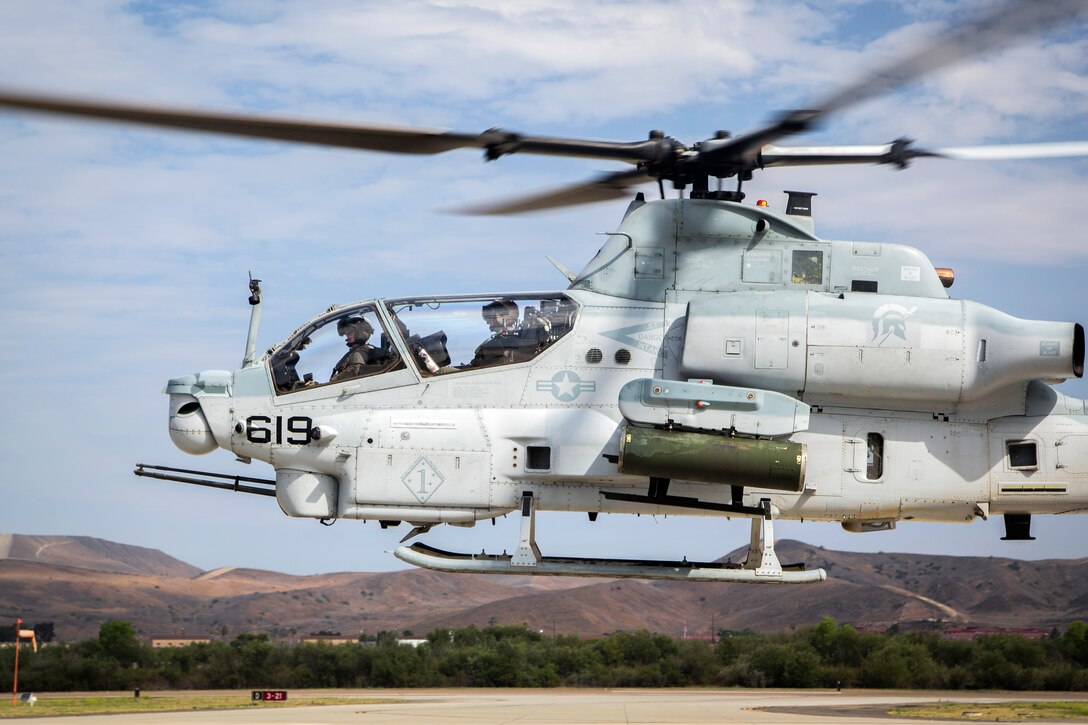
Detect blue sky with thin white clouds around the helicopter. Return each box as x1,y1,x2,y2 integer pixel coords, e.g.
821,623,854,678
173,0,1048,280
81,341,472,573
0,0,1088,573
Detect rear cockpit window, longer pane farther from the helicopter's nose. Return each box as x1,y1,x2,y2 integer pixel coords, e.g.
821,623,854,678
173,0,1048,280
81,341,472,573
387,295,578,376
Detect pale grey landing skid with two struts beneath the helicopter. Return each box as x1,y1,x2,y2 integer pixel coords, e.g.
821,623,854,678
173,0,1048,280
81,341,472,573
394,493,827,583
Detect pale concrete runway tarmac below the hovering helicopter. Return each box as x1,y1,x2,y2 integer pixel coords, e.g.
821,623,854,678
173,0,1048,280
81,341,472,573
14,689,1088,725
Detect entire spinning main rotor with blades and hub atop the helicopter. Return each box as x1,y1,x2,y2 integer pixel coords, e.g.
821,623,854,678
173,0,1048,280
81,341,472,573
0,0,1088,214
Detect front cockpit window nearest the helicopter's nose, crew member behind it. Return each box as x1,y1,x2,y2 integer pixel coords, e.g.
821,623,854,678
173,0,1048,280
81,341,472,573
271,305,406,393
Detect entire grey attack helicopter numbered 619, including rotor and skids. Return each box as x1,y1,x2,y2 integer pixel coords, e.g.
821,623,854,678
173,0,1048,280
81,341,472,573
0,2,1088,583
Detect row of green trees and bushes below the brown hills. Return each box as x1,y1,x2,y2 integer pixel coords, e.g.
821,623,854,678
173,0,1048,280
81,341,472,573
0,618,1088,691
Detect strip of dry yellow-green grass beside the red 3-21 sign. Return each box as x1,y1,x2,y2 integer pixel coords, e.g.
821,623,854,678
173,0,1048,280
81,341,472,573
0,692,399,718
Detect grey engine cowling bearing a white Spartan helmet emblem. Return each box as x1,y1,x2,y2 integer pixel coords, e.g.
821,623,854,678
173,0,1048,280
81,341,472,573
680,291,1085,409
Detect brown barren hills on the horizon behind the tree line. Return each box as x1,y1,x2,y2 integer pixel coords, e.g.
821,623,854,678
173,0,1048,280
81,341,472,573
0,534,1088,640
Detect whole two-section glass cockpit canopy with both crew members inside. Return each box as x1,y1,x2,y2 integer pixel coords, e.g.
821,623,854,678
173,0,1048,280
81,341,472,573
270,293,578,394
